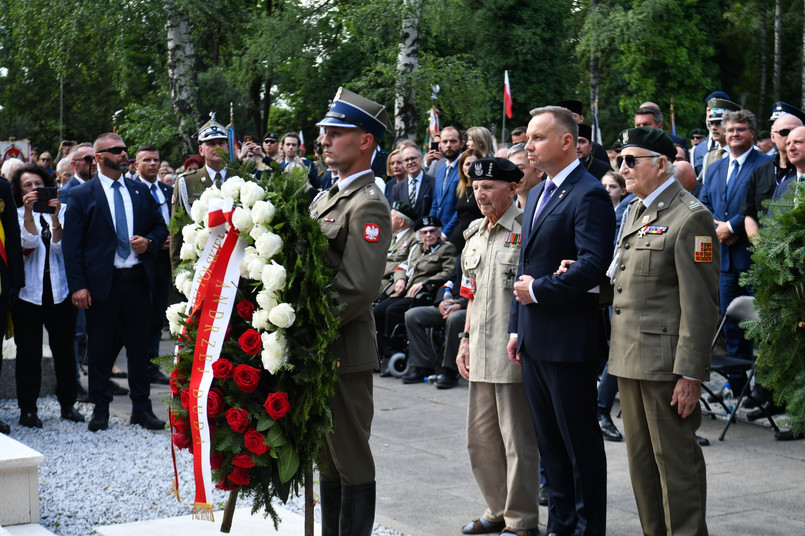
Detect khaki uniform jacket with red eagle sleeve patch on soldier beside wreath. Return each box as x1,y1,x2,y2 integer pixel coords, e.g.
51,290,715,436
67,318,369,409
310,172,391,374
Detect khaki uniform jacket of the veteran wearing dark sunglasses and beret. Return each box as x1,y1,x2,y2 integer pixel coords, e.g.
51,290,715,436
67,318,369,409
609,181,720,381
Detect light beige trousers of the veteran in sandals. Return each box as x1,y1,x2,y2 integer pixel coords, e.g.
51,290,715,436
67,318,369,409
467,382,539,529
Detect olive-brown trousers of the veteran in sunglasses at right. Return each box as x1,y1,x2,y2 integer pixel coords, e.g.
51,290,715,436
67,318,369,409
618,378,707,536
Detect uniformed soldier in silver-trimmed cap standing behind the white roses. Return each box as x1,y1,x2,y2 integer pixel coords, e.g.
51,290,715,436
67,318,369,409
170,112,229,271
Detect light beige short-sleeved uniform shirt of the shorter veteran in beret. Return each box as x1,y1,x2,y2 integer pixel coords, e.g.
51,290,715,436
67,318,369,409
461,203,523,383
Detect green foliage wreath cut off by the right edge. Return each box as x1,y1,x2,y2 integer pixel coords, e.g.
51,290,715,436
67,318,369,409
741,183,805,431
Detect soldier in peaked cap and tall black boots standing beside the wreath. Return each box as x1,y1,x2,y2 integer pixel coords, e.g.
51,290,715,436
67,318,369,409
310,88,392,536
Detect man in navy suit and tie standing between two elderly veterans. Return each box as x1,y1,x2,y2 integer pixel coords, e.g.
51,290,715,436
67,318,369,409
508,106,615,536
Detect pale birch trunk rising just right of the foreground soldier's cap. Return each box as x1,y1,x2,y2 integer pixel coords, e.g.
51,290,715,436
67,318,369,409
394,0,422,142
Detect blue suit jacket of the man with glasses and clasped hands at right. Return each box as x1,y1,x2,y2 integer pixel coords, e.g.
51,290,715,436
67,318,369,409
697,148,772,272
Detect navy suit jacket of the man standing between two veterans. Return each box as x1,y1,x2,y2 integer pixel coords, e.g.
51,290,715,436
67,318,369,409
509,163,615,362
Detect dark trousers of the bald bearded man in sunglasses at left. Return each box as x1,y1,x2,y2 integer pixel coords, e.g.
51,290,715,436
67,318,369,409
87,272,151,413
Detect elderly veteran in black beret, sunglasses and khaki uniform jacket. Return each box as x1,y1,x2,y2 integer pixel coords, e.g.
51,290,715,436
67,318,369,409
608,127,719,536
